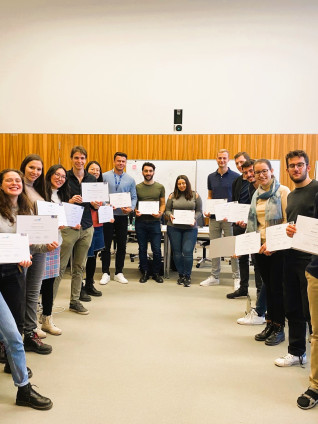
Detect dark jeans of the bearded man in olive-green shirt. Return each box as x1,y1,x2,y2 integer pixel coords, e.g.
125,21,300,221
135,219,161,274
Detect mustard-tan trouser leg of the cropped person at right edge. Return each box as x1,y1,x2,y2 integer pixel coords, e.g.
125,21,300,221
306,272,318,390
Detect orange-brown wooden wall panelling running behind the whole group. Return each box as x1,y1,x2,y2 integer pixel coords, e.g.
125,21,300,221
0,134,318,188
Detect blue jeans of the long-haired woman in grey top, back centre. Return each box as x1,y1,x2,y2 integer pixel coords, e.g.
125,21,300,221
167,225,198,277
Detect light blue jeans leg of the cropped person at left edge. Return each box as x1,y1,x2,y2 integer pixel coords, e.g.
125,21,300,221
0,293,29,387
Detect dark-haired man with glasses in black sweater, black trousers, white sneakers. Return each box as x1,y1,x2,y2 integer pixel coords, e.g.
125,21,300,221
274,150,318,367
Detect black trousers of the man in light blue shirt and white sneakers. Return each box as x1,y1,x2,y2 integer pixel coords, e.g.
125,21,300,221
101,215,128,274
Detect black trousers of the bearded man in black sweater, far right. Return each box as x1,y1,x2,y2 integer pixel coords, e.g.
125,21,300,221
284,250,311,356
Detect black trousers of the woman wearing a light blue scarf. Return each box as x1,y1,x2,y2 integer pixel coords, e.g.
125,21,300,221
255,250,285,325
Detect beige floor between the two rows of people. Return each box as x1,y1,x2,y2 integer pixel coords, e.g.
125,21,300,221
0,248,318,424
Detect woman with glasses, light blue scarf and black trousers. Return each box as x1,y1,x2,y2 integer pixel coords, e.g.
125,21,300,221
247,159,290,346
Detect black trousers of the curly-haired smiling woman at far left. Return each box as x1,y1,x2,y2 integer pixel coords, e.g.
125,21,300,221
0,264,26,334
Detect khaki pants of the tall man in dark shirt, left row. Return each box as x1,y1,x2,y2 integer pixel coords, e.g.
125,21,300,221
53,226,94,302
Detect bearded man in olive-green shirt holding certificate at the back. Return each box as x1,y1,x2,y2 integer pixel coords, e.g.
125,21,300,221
135,162,165,283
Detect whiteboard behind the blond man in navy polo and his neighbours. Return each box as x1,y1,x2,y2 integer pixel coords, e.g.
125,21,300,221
196,159,280,212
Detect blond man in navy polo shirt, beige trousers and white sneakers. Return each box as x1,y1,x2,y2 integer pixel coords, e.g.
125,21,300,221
200,149,240,286
